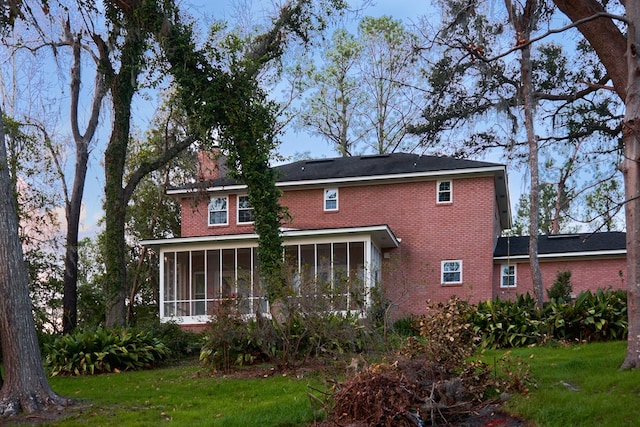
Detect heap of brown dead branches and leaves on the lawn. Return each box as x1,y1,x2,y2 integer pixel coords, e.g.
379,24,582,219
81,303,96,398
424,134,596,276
320,299,534,427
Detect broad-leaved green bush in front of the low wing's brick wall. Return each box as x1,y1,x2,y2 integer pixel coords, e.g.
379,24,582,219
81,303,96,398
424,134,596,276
545,289,628,341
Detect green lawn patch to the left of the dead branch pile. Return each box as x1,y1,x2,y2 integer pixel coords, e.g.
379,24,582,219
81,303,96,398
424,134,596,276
50,366,322,427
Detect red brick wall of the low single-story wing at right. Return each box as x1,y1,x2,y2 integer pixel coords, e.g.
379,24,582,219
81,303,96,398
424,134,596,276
493,257,627,300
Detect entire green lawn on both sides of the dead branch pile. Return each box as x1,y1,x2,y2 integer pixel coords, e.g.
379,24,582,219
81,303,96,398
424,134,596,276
36,342,640,427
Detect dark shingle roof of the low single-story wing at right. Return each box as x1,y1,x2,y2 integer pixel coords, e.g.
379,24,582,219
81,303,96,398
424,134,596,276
494,231,626,257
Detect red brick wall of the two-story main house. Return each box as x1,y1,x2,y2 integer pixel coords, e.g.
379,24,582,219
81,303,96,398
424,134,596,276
182,176,496,316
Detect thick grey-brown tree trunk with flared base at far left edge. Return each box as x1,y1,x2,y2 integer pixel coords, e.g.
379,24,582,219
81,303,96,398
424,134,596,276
0,105,71,415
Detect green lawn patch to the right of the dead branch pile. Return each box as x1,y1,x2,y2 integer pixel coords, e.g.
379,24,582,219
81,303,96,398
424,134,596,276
485,342,640,427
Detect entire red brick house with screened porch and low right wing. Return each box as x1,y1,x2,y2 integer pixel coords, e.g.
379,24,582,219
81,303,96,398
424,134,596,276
143,153,624,327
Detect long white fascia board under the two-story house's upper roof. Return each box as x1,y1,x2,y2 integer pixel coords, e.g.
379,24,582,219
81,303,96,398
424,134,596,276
167,166,506,195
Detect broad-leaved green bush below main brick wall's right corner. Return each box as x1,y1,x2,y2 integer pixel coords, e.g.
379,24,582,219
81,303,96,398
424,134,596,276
472,293,545,348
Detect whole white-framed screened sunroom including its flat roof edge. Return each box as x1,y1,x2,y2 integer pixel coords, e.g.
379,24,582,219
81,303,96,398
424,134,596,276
142,225,399,325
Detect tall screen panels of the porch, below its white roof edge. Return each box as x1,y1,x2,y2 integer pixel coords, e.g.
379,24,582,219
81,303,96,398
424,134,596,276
161,241,380,322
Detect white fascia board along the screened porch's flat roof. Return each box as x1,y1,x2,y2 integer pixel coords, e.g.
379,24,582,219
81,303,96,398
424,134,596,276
140,225,400,247
